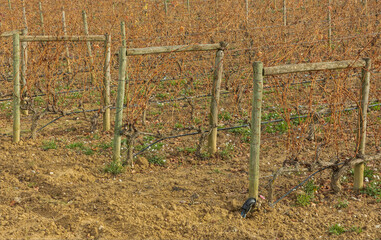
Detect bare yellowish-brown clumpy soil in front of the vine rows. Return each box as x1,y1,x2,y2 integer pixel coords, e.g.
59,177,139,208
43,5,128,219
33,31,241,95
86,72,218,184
0,115,381,239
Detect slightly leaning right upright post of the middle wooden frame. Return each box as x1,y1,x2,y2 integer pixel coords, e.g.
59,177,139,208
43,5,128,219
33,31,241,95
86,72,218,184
208,45,224,155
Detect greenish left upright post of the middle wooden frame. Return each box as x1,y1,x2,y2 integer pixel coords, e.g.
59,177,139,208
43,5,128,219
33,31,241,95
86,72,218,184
113,47,127,162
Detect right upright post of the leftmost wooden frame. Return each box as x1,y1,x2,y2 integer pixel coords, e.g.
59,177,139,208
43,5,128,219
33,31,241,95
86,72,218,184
103,34,111,131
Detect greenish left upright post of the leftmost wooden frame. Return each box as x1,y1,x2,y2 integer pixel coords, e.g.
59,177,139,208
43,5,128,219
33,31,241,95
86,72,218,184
13,33,21,143
